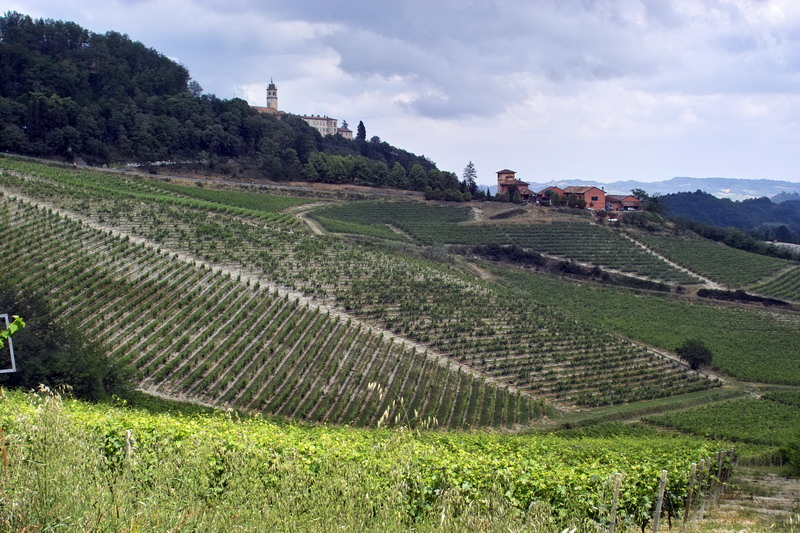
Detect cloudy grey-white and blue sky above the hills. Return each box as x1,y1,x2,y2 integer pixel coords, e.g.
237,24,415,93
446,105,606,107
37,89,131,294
10,0,800,183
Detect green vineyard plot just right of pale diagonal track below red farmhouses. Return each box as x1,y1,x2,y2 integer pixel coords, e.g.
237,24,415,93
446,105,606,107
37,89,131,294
635,233,796,288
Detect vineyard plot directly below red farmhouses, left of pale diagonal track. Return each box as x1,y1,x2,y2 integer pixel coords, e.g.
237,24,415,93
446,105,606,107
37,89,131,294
314,202,699,284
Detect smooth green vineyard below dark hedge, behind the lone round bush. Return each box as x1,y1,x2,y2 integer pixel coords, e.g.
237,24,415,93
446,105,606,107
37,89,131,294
494,268,800,385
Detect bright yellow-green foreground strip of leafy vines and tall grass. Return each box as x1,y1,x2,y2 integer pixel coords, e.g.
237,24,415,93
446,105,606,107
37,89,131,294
0,390,724,531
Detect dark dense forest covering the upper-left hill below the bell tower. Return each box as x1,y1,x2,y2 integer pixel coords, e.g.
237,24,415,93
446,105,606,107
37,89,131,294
0,12,459,191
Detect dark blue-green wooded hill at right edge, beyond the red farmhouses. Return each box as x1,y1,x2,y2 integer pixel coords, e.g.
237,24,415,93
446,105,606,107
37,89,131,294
661,191,800,243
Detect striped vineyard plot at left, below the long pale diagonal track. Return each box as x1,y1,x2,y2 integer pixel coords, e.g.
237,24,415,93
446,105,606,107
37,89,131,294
0,198,541,427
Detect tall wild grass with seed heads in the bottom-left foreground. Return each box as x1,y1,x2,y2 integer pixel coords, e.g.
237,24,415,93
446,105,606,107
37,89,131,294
0,390,594,532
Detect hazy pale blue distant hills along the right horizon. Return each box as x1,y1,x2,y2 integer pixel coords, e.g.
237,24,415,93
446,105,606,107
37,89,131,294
522,177,800,200
